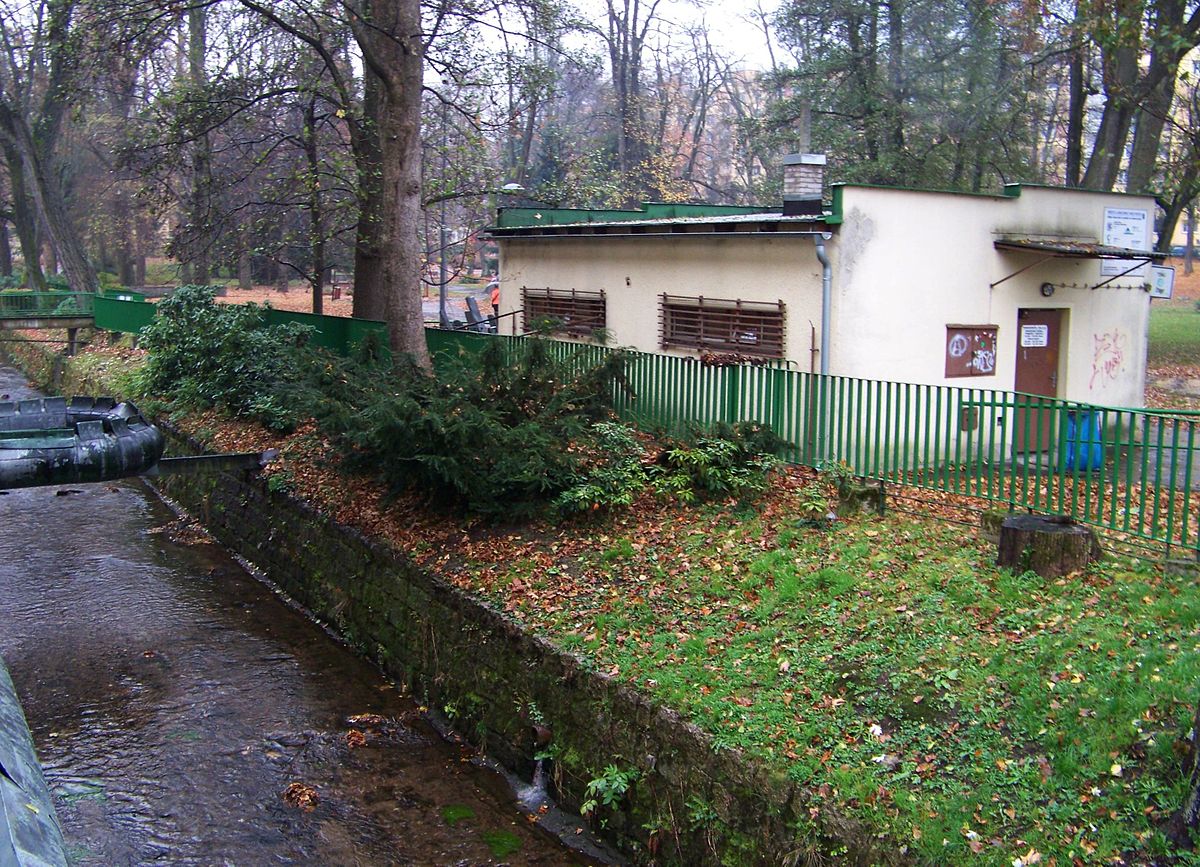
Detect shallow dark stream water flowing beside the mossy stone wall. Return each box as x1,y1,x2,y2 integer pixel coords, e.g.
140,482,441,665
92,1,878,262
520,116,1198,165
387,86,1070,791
0,370,604,866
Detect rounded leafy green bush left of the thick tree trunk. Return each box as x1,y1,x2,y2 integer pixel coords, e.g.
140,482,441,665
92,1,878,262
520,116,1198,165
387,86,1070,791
138,286,319,430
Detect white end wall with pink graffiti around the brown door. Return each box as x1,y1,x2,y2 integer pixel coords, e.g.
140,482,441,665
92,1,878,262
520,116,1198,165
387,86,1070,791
830,187,1154,406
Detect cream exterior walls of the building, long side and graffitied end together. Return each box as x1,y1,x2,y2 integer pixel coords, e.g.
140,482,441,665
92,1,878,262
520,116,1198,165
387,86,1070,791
499,186,1154,407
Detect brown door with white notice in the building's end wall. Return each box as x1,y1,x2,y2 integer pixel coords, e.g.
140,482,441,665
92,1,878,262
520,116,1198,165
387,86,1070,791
1013,309,1062,452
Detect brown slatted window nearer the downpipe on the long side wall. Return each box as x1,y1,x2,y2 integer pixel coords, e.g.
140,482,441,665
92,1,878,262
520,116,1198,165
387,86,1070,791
659,294,785,358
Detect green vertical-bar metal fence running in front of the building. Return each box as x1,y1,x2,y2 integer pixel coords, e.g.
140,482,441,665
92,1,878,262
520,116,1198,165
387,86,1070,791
427,329,1200,556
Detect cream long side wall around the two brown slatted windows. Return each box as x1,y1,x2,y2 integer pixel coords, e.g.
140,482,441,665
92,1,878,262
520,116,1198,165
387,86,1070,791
499,234,821,370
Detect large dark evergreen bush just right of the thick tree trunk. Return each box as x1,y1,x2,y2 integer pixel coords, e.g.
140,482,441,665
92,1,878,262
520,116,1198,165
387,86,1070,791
320,341,624,519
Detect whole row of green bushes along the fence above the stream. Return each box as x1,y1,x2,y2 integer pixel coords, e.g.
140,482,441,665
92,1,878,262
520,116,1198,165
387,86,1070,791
136,286,778,519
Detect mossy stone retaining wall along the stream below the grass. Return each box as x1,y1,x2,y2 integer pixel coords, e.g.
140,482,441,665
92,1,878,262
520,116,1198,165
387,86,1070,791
4,333,904,866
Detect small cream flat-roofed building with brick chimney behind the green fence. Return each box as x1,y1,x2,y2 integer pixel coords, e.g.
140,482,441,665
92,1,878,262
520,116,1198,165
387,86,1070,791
492,163,1159,406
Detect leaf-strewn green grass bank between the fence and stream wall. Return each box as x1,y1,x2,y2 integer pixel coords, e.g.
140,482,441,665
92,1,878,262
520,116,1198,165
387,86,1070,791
444,475,1200,866
